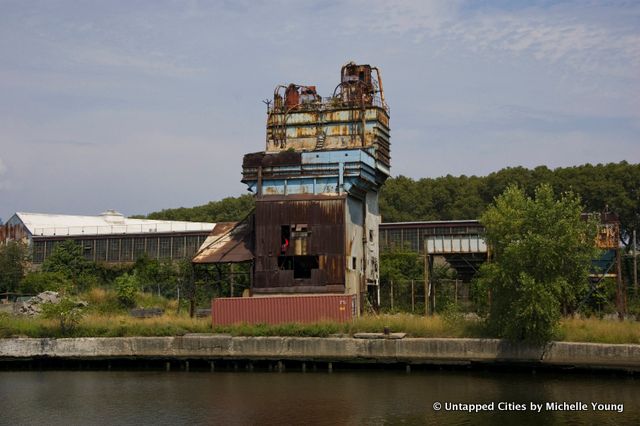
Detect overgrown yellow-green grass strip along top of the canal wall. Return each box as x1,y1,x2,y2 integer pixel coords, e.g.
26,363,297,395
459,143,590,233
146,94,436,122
0,288,640,344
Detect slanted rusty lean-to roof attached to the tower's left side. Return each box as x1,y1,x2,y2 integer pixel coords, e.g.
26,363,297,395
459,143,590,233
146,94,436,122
193,217,253,263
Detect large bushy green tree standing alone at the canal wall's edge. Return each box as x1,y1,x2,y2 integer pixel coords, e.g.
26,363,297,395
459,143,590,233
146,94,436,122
478,184,596,342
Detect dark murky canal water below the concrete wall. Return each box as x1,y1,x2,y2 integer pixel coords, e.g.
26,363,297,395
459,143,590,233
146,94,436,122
0,369,640,426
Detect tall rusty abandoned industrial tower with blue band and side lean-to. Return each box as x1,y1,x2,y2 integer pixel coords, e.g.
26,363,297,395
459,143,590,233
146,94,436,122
194,63,390,312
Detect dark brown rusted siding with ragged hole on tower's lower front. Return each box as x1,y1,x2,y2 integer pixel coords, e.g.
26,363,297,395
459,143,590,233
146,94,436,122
253,196,345,293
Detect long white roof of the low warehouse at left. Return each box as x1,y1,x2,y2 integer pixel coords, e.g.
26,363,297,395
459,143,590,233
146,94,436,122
16,210,216,236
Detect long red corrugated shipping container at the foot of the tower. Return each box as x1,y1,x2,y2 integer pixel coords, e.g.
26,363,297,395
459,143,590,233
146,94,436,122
211,295,355,326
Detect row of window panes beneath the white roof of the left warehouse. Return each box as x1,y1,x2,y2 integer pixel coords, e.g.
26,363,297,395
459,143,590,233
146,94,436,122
32,235,206,263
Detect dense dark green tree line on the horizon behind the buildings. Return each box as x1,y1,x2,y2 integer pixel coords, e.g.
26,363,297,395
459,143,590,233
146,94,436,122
143,161,640,245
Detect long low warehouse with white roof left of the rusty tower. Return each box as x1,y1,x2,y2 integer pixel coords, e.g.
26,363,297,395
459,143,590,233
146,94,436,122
0,210,216,265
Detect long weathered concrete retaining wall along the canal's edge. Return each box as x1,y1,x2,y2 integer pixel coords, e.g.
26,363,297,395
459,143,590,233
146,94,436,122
0,334,640,371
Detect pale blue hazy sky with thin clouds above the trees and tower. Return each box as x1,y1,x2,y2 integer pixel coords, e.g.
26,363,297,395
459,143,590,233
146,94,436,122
0,0,640,220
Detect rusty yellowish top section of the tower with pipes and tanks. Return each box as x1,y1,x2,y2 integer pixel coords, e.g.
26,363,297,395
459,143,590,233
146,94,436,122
264,63,391,170
